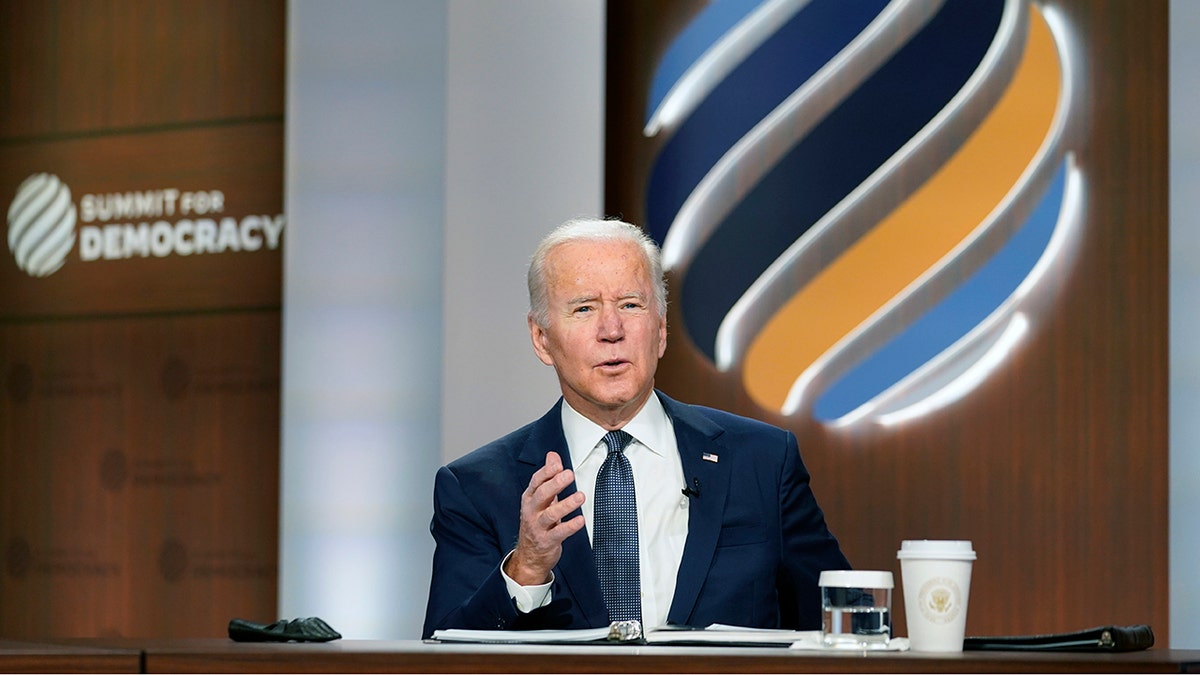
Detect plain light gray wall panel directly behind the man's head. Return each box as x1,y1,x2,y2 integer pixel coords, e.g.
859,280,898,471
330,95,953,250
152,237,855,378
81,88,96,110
442,0,605,460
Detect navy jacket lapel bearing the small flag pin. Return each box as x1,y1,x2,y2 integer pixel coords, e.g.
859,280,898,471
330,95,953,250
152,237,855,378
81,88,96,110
659,394,731,623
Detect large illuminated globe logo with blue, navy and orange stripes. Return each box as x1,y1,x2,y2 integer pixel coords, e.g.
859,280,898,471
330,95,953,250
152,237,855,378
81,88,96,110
643,0,1087,426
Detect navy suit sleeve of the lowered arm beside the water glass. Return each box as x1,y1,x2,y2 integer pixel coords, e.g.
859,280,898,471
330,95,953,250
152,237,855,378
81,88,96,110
778,431,850,631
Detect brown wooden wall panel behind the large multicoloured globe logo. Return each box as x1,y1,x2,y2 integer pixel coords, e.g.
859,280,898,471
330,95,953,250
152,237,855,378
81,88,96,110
606,0,1169,644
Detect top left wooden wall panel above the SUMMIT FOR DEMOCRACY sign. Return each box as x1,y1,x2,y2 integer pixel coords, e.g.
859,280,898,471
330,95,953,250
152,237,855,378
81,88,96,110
0,0,287,139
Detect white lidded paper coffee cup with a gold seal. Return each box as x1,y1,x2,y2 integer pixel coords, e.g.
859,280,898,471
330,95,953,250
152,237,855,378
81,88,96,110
896,539,976,652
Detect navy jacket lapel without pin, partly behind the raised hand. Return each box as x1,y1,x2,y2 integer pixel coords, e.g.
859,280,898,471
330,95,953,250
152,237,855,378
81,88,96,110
518,399,608,627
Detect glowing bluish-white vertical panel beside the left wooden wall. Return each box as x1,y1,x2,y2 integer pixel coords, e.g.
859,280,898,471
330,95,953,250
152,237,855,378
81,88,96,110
282,0,446,639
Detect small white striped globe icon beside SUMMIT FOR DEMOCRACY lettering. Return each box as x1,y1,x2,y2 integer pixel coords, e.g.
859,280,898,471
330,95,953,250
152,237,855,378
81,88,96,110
8,173,76,276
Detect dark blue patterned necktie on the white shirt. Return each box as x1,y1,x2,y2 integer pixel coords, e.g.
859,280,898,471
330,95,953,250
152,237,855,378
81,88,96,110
592,429,642,621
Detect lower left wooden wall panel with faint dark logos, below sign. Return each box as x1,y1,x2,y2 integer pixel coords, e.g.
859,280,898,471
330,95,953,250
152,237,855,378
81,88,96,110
0,311,280,638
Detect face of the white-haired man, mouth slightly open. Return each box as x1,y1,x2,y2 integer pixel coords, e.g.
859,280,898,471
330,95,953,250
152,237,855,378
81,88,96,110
529,241,667,426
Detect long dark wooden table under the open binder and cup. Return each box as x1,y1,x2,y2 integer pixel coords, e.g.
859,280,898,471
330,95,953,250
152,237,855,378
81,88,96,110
24,638,1200,673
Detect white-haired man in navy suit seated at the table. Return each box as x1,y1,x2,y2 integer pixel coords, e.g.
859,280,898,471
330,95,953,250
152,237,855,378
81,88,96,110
424,220,850,638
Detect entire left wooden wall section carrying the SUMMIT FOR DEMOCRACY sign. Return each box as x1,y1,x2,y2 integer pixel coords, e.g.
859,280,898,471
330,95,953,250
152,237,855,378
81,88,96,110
0,0,286,638
